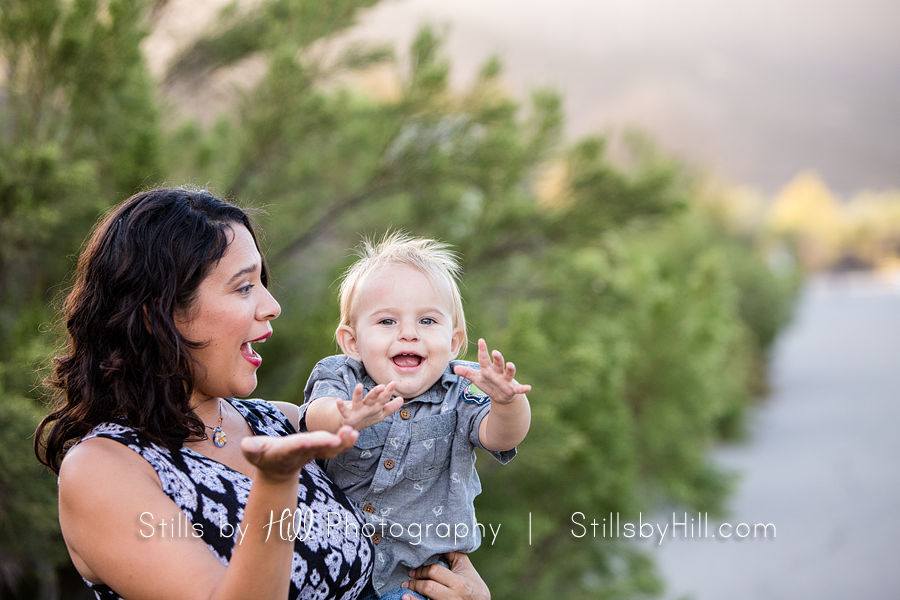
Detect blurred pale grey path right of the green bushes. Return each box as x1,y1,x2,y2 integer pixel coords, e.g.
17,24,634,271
648,276,900,600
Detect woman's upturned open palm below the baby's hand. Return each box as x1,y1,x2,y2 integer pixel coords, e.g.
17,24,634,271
241,426,359,482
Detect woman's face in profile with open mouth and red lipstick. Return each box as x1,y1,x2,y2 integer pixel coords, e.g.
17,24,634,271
175,223,281,405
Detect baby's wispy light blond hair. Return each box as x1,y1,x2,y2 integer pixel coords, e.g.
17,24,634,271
338,231,468,356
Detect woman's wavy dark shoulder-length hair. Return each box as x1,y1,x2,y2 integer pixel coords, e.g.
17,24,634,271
34,188,268,473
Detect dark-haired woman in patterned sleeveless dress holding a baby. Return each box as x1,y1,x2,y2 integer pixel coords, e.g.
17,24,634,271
35,189,488,599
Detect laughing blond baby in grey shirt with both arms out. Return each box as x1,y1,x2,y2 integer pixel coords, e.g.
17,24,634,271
302,233,531,598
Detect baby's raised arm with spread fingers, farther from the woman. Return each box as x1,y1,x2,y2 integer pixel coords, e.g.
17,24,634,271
454,339,531,452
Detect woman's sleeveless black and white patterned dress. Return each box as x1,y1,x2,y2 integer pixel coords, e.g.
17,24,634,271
82,399,372,600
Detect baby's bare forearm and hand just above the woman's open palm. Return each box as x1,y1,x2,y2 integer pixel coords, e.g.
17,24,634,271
306,381,403,433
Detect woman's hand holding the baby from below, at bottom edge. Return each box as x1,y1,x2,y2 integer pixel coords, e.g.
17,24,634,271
403,552,491,600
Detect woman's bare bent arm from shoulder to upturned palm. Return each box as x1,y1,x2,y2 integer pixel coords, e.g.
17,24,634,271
59,427,357,600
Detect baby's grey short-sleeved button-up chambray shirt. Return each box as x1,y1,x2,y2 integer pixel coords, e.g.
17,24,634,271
300,355,516,594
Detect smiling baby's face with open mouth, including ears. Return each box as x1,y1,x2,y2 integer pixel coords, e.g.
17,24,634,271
339,264,462,400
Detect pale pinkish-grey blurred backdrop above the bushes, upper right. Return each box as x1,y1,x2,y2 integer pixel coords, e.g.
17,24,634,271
355,0,900,197
